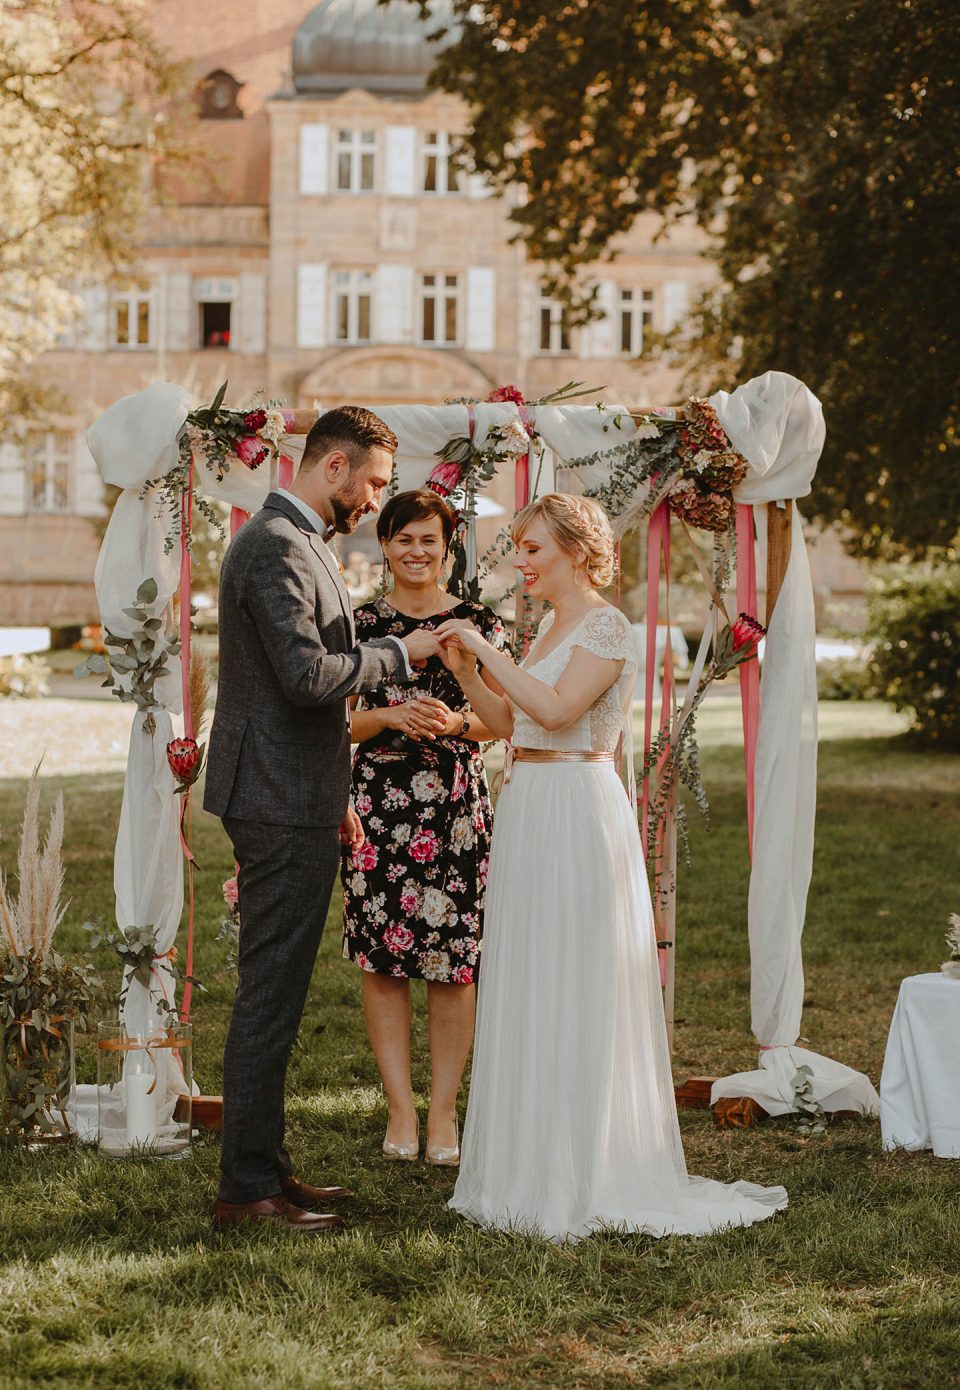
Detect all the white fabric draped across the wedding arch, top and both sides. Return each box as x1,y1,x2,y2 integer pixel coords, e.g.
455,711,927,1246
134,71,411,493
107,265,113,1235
88,373,877,1134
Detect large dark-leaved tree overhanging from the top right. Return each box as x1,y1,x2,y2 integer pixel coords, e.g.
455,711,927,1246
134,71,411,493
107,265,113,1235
422,0,960,555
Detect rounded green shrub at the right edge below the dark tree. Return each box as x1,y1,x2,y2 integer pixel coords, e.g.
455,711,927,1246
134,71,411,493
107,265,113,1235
867,552,960,748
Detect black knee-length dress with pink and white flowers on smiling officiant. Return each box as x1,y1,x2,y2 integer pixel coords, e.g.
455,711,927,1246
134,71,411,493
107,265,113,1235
340,599,504,984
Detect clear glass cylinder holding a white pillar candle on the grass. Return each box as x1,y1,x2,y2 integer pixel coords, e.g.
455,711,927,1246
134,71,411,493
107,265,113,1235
97,1022,193,1158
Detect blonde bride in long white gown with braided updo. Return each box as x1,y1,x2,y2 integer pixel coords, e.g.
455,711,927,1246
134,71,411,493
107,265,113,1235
438,493,786,1240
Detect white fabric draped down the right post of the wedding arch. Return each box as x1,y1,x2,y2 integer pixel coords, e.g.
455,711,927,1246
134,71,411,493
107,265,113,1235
711,371,879,1115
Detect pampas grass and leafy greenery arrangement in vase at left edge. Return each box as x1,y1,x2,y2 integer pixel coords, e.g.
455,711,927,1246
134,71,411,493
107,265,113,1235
0,765,103,1144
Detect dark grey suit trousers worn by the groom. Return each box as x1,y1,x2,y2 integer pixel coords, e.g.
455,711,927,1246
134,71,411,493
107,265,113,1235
220,817,340,1202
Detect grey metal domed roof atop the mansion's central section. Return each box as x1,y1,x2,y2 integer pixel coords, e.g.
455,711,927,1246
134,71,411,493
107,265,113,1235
293,0,452,96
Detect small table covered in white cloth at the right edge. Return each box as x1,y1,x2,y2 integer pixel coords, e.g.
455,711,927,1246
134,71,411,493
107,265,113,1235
879,974,960,1158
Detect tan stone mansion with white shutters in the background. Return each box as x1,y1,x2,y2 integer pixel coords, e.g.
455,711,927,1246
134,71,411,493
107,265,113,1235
0,0,855,626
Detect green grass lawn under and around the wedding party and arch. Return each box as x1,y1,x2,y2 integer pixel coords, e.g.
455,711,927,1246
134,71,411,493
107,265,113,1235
0,701,960,1390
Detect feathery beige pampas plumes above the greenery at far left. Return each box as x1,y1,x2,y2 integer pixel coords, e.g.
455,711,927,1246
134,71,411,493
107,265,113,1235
0,763,67,956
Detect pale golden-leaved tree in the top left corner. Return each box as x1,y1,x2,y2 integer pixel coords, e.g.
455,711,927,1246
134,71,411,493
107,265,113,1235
0,0,188,420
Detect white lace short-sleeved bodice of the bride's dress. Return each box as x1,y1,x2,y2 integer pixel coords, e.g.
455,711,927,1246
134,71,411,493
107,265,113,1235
513,605,638,753
